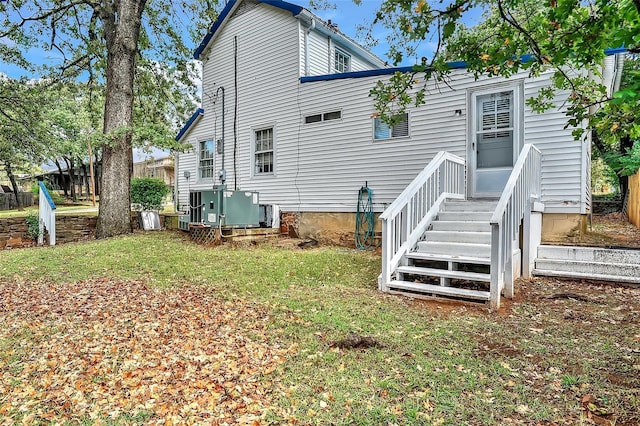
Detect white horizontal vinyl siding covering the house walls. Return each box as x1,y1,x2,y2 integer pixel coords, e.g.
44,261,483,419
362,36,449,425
176,0,585,213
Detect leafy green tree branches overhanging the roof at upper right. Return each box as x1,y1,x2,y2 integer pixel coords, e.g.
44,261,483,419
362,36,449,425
372,0,640,145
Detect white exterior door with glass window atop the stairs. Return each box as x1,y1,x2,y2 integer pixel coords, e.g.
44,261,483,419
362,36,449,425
469,88,521,198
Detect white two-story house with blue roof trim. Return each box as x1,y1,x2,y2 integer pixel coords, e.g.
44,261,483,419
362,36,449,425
176,0,616,306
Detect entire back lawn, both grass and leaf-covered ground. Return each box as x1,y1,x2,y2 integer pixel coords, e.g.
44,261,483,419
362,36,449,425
0,233,640,425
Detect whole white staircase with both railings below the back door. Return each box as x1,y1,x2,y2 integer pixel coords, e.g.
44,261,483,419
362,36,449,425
378,144,543,309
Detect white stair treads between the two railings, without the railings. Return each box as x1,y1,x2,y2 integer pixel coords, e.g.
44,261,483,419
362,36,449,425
389,200,497,302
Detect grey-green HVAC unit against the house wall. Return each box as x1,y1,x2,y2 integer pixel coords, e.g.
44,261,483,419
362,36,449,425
189,185,260,228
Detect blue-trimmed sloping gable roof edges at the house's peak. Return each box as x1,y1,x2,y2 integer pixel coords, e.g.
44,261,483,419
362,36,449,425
193,0,385,67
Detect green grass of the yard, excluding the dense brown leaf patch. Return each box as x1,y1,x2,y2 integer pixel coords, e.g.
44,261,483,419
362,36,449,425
0,233,640,425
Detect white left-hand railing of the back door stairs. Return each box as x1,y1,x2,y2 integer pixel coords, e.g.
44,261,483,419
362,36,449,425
378,152,465,291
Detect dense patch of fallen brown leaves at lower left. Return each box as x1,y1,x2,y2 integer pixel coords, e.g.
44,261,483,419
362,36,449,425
0,279,288,424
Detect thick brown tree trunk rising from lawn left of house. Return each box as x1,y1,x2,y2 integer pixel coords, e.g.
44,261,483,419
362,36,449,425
96,0,146,238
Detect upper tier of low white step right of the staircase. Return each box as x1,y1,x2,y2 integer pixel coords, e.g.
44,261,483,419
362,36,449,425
538,245,640,264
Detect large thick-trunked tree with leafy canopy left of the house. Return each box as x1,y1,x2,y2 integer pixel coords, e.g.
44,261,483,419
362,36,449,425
0,0,216,238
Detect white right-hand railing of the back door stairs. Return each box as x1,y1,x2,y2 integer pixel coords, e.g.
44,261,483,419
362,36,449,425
489,144,542,309
